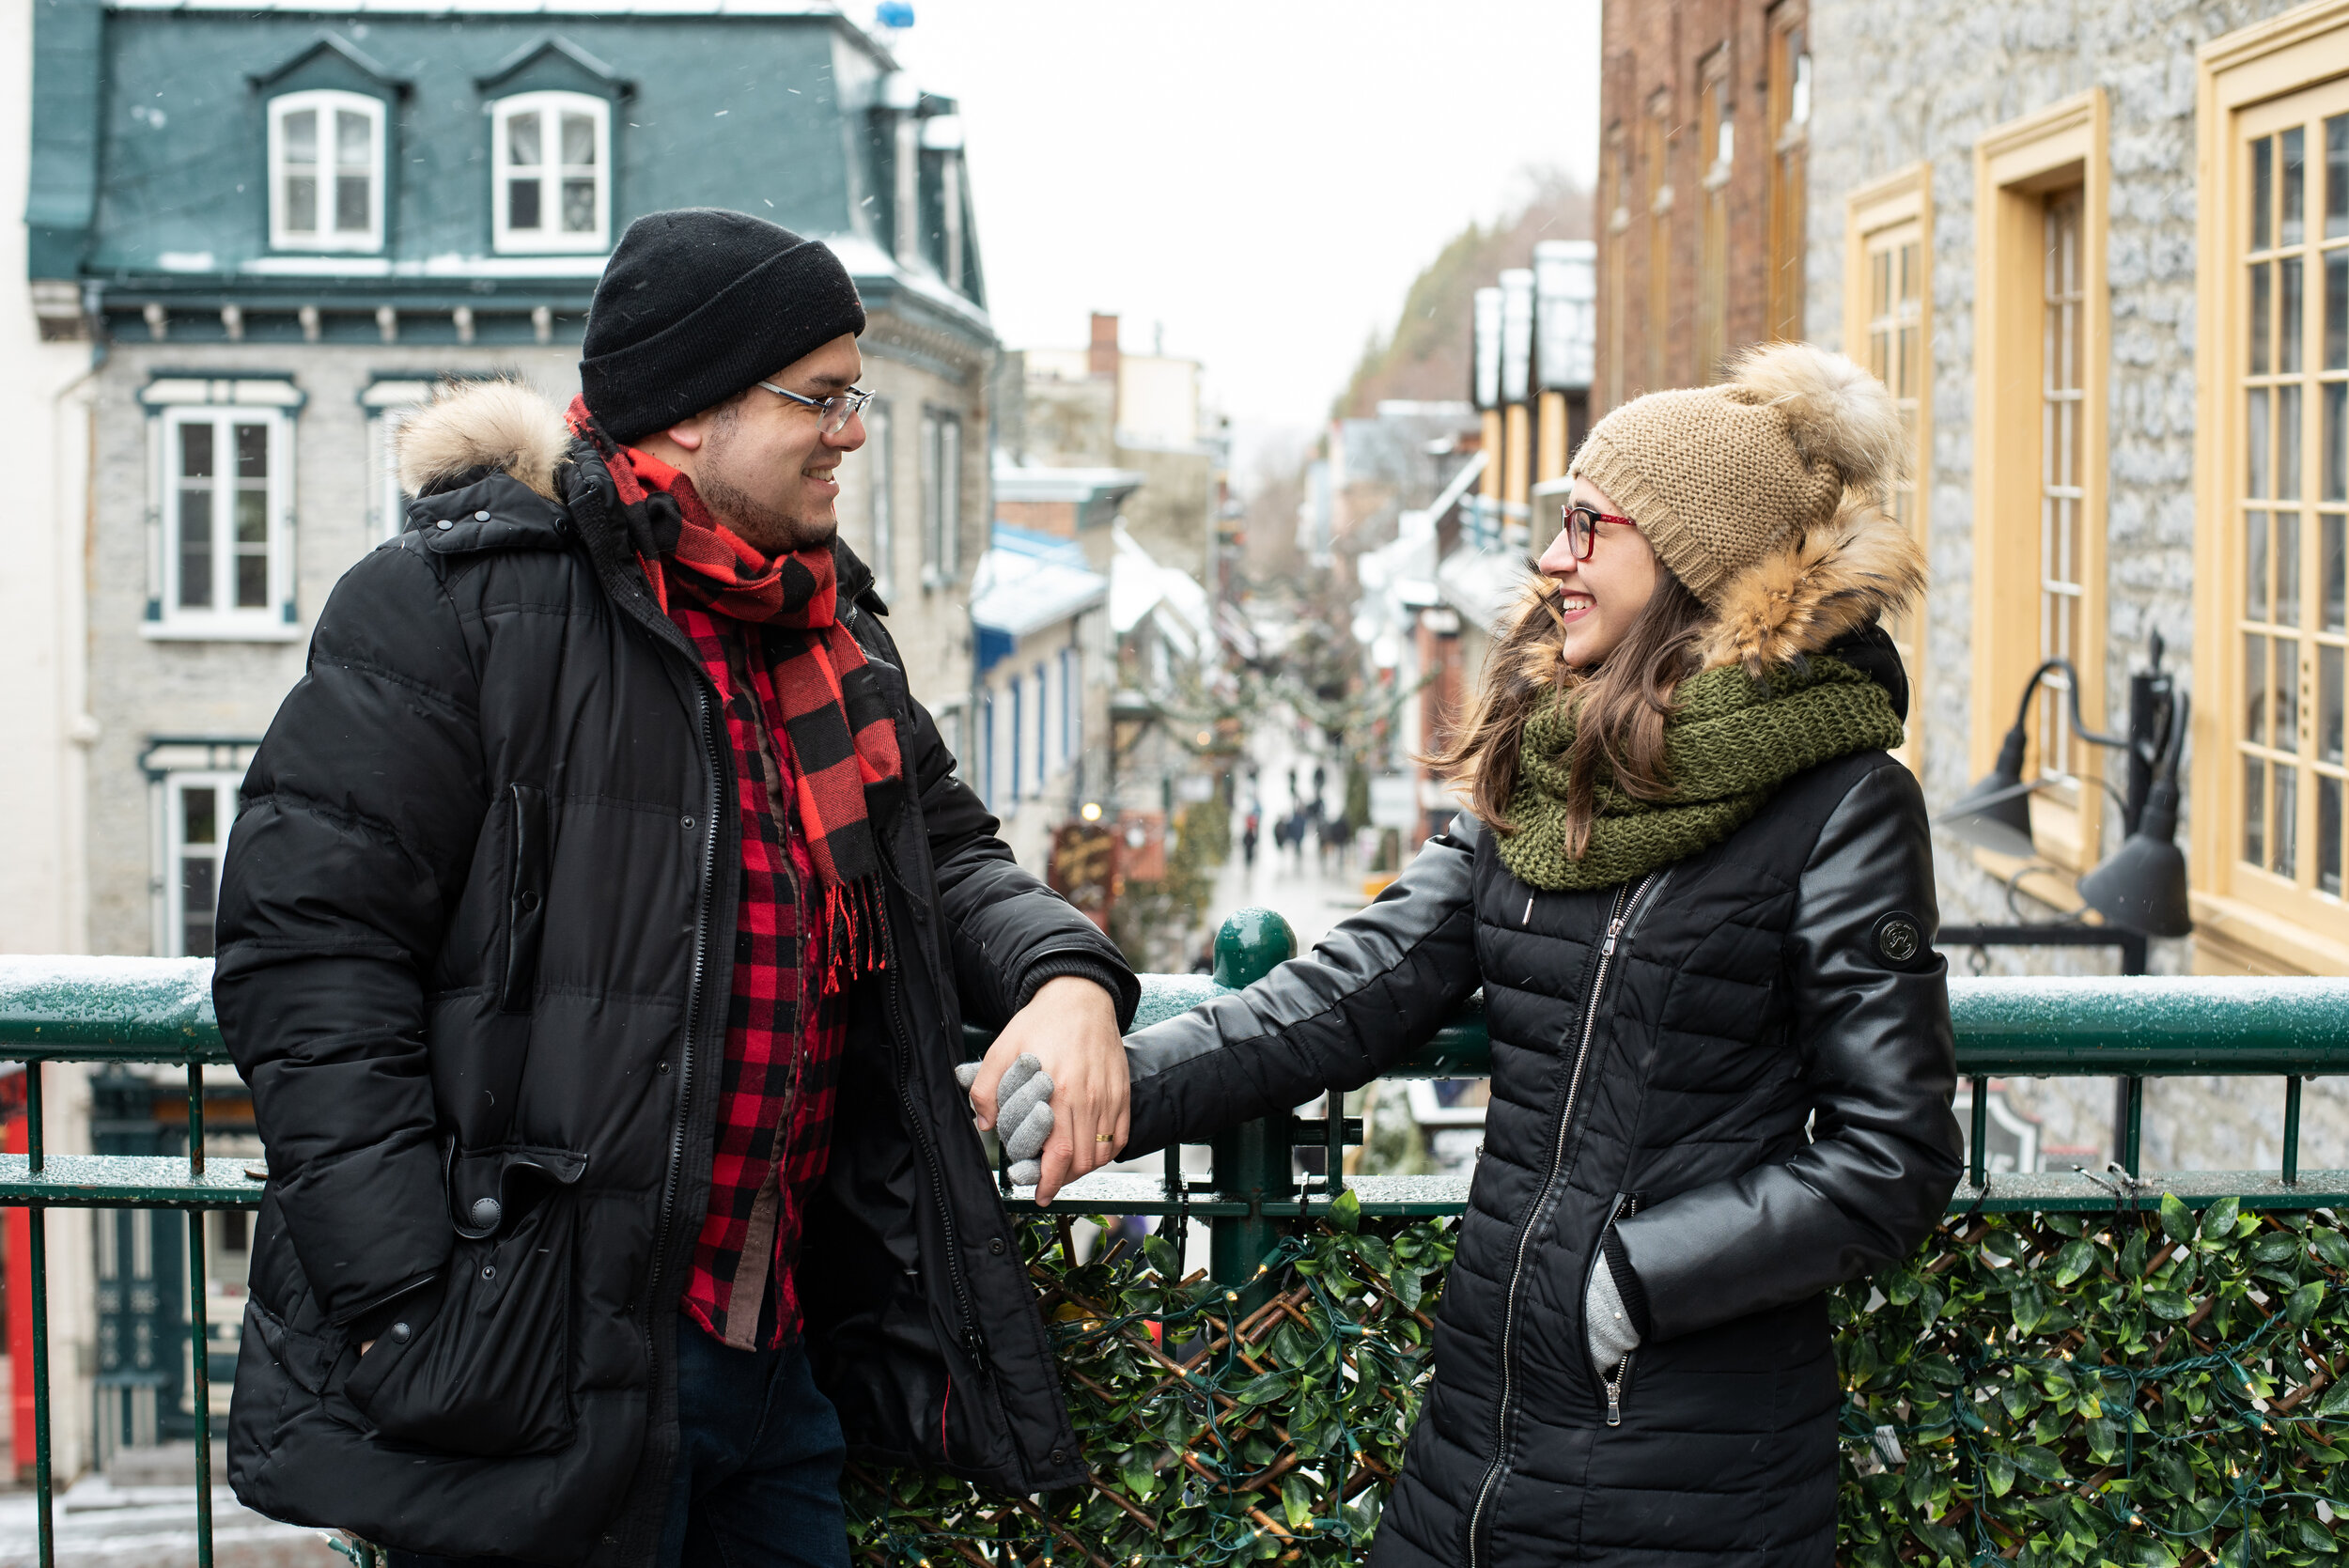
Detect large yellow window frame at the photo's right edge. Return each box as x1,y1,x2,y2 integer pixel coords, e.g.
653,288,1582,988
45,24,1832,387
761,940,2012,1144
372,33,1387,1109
2187,0,2349,974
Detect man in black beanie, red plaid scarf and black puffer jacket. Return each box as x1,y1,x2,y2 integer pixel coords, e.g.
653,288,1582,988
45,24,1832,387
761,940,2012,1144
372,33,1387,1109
214,211,1140,1568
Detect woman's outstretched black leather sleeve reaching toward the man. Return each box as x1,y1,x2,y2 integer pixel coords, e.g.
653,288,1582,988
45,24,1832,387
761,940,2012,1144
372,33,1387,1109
1126,816,1483,1157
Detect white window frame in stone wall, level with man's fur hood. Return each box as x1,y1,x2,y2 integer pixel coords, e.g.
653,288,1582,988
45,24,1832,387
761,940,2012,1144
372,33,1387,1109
148,401,301,641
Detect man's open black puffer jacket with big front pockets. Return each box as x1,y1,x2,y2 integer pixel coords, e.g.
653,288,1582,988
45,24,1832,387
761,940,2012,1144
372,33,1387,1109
214,390,1140,1566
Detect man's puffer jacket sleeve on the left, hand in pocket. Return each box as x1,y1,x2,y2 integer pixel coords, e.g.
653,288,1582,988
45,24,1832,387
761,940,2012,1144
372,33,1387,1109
211,545,489,1322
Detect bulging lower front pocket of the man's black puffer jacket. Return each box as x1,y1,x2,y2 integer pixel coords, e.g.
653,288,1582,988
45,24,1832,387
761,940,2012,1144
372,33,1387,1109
343,1192,578,1455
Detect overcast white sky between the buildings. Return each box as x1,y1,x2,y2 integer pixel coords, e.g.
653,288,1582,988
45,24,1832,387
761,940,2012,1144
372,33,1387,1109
895,0,1600,474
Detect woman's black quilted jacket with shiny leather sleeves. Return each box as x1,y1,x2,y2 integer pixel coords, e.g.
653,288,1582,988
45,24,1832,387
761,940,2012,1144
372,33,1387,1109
1128,634,1962,1568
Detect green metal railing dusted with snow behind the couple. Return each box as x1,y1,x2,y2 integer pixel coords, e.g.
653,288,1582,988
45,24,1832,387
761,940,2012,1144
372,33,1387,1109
0,908,2349,1568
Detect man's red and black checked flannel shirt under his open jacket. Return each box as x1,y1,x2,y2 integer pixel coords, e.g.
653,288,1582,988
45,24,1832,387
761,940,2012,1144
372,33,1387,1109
670,594,846,1350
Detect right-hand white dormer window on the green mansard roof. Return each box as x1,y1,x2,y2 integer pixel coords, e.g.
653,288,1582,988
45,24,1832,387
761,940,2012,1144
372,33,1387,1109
491,91,611,254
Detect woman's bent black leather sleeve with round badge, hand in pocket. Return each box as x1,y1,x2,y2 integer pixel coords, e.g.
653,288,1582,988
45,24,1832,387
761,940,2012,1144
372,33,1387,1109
1616,763,1964,1341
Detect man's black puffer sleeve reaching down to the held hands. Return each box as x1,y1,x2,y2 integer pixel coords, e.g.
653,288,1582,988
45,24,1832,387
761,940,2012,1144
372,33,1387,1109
907,702,1142,1028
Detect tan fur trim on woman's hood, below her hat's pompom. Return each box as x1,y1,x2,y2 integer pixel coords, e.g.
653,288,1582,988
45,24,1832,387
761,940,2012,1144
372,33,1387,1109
1701,492,1924,681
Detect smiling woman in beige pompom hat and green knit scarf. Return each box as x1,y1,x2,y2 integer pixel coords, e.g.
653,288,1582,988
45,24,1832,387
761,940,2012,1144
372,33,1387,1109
1128,345,1964,1568
